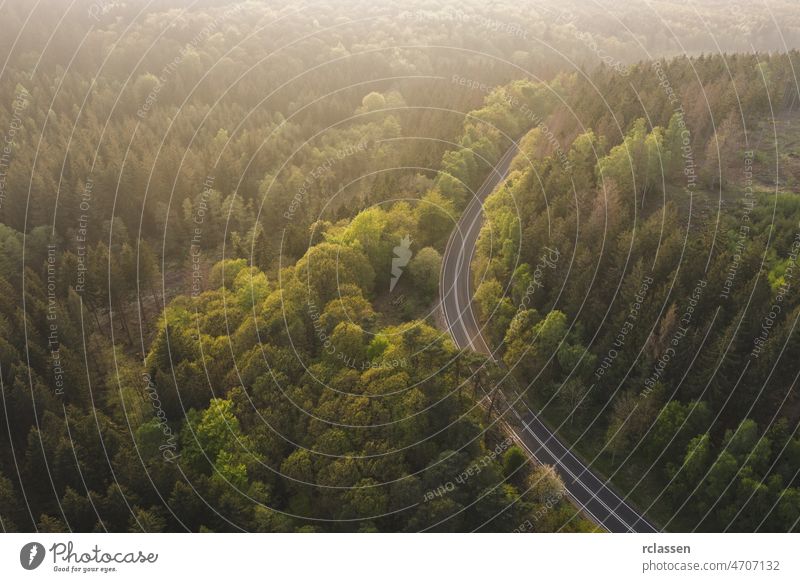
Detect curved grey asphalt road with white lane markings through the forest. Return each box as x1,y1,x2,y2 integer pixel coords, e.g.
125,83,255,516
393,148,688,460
439,146,658,533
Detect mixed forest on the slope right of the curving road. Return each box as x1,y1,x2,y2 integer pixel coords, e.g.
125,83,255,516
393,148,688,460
473,52,800,531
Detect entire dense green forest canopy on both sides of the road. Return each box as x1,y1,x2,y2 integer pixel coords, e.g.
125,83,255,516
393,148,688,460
0,0,800,532
